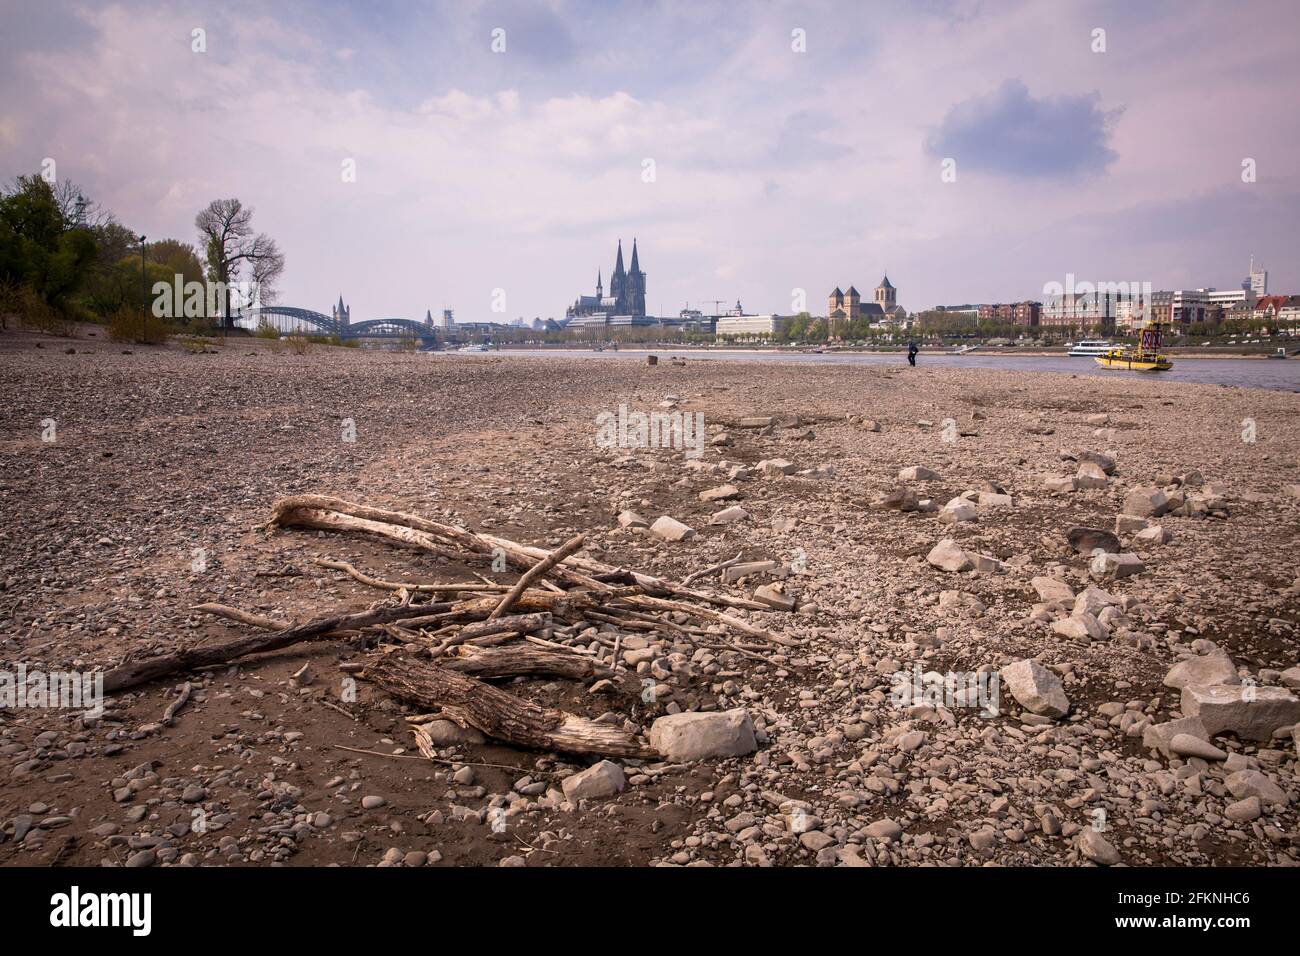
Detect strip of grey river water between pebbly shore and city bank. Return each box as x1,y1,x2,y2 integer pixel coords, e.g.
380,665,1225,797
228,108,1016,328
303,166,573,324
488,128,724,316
463,349,1300,392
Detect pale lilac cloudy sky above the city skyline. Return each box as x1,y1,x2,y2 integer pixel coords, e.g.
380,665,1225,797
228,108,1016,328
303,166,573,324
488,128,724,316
0,0,1300,321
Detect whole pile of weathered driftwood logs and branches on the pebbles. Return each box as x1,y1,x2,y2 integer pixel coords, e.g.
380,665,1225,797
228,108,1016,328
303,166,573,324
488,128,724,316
104,494,800,757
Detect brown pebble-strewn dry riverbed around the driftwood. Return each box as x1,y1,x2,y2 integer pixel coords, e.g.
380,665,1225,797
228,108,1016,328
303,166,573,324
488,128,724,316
0,333,1300,866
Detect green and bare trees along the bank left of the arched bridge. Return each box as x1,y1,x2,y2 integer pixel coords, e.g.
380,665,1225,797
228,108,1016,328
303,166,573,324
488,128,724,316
0,174,285,341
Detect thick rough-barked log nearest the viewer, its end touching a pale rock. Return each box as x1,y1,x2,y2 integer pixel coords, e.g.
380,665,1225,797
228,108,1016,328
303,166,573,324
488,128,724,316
361,653,657,757
